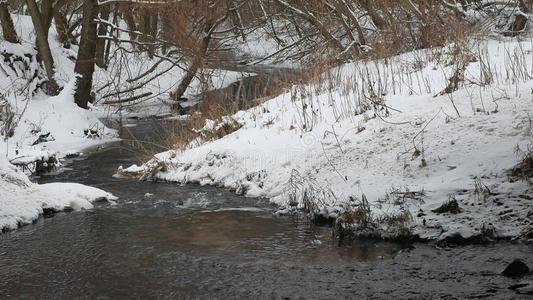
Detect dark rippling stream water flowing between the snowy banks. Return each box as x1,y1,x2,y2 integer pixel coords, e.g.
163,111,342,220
0,121,533,299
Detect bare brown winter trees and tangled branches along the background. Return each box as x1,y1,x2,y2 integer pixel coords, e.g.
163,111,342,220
0,0,533,108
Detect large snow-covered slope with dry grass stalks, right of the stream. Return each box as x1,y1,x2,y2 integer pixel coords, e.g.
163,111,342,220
127,40,533,239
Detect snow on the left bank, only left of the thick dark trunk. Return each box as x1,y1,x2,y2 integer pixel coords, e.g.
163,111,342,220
0,15,117,231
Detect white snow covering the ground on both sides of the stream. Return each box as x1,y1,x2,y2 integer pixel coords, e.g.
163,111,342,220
0,11,533,239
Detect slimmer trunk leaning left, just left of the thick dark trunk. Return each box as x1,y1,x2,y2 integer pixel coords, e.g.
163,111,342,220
26,0,59,95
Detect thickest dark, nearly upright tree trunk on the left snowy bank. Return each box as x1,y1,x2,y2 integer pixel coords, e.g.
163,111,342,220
74,0,98,109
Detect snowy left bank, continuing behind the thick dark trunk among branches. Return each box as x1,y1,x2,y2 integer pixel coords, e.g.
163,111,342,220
0,14,270,231
